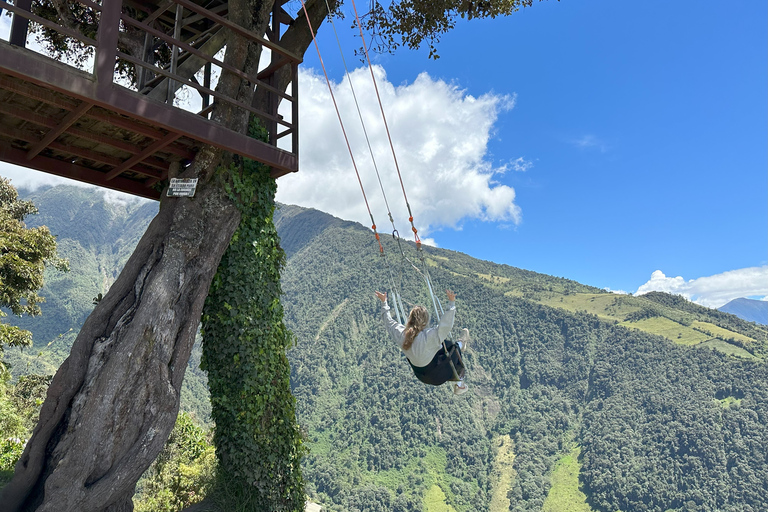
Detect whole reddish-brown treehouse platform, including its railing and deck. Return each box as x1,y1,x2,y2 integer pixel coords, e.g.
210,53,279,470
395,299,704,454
0,0,301,199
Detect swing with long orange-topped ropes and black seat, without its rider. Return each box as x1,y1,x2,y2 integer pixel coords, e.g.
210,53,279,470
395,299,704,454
301,0,466,389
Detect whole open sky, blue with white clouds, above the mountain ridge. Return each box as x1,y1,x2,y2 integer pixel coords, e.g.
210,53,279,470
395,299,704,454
0,0,768,306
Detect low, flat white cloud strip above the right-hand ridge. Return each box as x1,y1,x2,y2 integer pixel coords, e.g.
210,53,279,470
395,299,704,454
636,265,768,308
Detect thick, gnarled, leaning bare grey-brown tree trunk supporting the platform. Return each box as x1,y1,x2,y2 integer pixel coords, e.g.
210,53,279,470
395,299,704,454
0,0,335,512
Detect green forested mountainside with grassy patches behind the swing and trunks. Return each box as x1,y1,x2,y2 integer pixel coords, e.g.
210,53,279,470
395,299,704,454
7,187,768,512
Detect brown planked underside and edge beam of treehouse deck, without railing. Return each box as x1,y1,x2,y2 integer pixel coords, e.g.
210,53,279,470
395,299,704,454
0,2,298,199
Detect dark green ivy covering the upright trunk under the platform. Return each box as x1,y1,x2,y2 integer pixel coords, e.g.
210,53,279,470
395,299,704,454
202,119,305,511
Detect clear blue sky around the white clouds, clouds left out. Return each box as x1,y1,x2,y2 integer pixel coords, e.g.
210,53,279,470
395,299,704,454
284,0,768,304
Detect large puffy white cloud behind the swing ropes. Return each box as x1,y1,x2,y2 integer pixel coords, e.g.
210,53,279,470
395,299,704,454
278,66,530,234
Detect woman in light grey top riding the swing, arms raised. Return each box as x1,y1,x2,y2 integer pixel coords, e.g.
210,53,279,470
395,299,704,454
376,290,469,395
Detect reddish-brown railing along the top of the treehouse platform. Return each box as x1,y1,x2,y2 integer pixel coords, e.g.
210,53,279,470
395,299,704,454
0,0,301,155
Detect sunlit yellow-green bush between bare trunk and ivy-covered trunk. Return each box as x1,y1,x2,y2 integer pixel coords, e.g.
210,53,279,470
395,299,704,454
133,412,216,512
